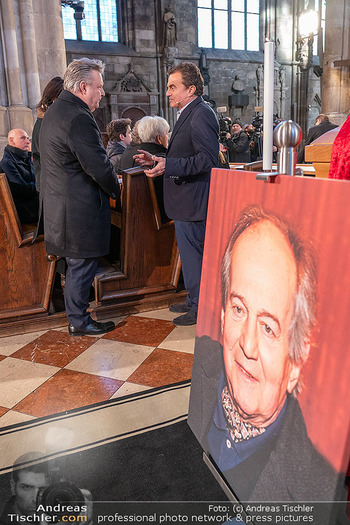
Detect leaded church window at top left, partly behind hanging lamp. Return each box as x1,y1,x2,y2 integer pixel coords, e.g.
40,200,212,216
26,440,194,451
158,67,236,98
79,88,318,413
62,0,118,42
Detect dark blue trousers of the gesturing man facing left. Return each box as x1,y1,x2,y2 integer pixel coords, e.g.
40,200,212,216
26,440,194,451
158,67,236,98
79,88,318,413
174,219,206,312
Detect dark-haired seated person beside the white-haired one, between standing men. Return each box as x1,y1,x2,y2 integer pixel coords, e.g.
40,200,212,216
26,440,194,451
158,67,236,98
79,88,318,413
107,118,131,174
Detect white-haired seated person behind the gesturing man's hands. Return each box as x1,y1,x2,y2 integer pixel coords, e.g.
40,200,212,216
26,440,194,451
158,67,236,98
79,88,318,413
120,116,169,222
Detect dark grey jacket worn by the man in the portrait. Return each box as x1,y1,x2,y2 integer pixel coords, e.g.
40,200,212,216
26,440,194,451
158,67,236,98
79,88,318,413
188,336,341,502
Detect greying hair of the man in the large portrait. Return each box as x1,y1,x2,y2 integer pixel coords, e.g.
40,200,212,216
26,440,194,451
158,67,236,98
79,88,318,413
221,205,317,396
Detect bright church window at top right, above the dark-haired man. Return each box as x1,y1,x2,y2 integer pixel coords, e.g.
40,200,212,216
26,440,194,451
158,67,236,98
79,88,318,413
197,0,260,51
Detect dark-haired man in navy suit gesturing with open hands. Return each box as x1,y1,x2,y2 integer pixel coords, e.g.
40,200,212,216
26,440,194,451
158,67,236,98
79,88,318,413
136,62,219,326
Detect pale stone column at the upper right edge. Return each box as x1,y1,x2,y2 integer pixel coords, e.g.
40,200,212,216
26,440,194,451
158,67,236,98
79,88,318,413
322,0,350,124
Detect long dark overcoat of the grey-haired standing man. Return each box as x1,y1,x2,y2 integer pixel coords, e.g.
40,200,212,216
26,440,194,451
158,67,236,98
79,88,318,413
40,90,120,259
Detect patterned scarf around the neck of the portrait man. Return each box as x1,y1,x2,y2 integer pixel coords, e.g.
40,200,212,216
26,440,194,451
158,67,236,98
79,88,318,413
221,386,265,443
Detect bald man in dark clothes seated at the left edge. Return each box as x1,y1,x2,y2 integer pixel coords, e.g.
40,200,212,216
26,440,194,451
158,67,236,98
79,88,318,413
0,129,39,224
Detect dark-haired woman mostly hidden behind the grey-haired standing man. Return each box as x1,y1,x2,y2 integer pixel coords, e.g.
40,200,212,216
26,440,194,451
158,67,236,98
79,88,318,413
32,77,63,191
